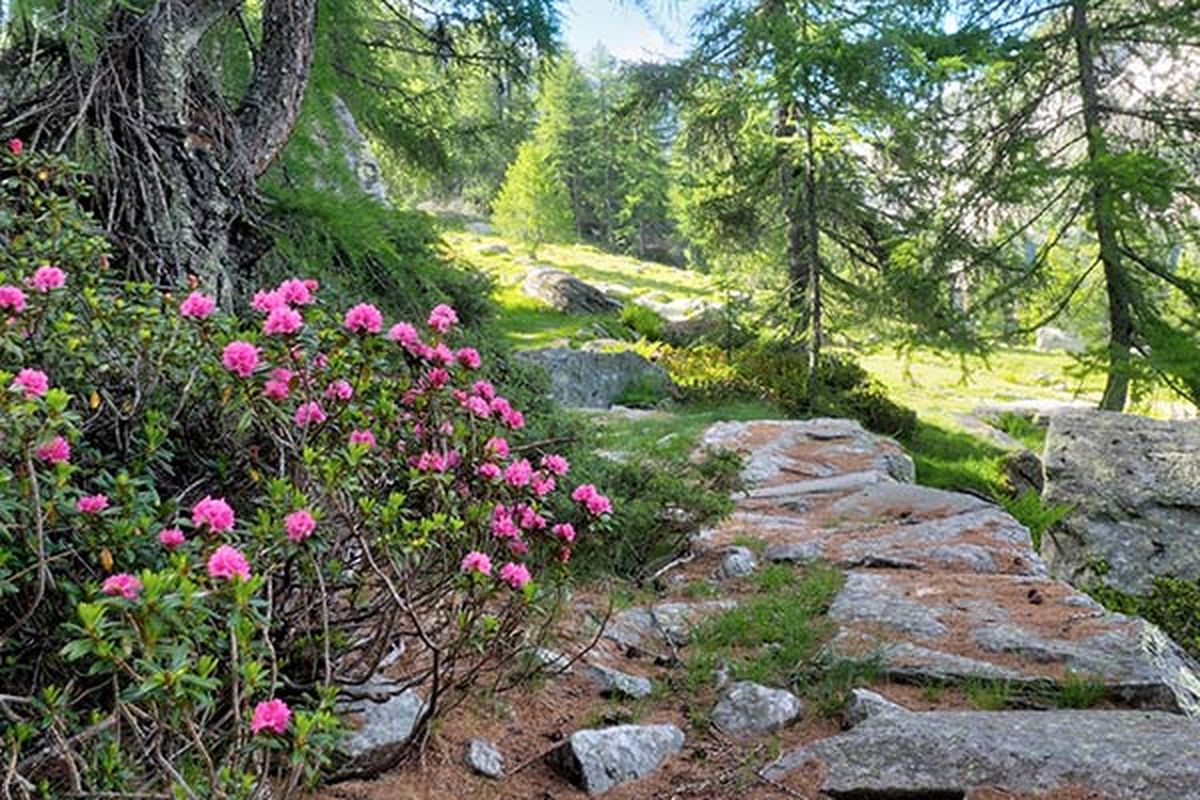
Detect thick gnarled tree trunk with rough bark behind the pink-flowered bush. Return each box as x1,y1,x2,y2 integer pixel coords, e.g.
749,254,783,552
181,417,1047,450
41,0,317,293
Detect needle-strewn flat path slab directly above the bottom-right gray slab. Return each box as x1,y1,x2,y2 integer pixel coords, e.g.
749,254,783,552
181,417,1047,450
829,570,1200,714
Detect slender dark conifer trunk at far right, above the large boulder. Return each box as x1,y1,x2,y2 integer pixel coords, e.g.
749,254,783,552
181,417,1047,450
1072,0,1134,411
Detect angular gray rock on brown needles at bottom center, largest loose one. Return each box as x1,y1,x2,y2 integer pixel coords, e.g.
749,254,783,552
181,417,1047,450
547,724,684,796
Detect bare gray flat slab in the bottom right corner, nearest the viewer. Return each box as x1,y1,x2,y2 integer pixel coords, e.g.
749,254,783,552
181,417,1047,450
763,711,1200,800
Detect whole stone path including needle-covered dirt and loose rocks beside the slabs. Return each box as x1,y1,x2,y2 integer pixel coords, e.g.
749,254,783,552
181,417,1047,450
322,420,1200,800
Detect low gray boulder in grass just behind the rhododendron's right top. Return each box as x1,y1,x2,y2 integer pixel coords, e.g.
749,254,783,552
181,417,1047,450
518,348,674,408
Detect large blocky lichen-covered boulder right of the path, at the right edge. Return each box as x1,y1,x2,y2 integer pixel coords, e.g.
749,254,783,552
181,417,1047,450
1043,411,1200,594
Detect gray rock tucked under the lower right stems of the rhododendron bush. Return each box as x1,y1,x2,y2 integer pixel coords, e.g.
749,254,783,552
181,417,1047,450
338,681,426,775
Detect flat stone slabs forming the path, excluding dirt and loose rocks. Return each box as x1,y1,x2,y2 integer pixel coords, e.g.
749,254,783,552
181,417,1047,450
696,420,1200,800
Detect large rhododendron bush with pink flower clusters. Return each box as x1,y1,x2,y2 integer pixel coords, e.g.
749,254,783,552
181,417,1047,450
0,142,612,798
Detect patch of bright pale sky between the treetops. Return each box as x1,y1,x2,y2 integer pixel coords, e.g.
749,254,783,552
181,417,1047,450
563,0,702,61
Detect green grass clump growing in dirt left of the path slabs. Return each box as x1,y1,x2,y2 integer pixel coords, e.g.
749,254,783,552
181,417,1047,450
685,565,841,691
